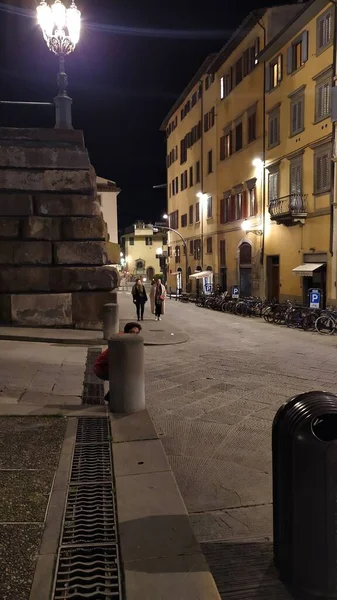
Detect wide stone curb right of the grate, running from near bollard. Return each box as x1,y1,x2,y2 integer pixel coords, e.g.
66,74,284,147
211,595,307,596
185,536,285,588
110,410,220,600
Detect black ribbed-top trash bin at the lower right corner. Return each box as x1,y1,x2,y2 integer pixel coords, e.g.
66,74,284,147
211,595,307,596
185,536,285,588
272,392,337,599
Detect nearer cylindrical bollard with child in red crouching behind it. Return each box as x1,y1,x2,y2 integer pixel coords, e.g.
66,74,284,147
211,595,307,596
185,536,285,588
109,334,145,414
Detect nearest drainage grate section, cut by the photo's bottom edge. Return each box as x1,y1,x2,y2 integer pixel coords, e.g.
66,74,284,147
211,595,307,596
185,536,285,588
54,545,122,600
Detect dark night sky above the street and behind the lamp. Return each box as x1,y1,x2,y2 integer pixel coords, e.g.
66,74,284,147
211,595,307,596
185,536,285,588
0,0,298,229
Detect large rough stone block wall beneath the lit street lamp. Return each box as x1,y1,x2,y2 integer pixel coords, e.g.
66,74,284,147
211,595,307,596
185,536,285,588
0,128,118,329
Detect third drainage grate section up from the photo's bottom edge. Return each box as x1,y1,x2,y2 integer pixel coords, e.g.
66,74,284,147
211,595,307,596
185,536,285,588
70,444,112,484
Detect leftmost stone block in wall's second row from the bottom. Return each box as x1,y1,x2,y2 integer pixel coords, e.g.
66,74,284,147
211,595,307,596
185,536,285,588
0,266,50,293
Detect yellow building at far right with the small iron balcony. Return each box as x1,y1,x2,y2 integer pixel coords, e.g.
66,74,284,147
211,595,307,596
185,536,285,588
260,1,336,303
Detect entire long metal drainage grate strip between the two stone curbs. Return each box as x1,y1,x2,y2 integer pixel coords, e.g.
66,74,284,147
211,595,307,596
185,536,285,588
53,417,122,600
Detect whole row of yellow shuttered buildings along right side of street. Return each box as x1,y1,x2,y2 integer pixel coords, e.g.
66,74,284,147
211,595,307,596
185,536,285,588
162,0,334,300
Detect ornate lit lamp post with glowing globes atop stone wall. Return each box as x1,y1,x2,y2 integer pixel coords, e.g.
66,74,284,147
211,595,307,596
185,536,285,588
37,0,81,129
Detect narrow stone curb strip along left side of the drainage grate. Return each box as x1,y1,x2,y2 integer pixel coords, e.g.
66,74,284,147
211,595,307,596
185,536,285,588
29,418,77,600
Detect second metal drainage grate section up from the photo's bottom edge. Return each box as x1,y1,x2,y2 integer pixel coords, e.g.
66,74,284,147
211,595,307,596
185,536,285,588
62,485,116,546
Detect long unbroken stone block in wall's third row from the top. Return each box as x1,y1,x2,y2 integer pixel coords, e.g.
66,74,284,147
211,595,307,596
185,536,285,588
0,169,96,194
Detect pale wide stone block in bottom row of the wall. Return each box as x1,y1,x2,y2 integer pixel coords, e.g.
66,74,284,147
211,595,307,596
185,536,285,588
11,294,71,327
